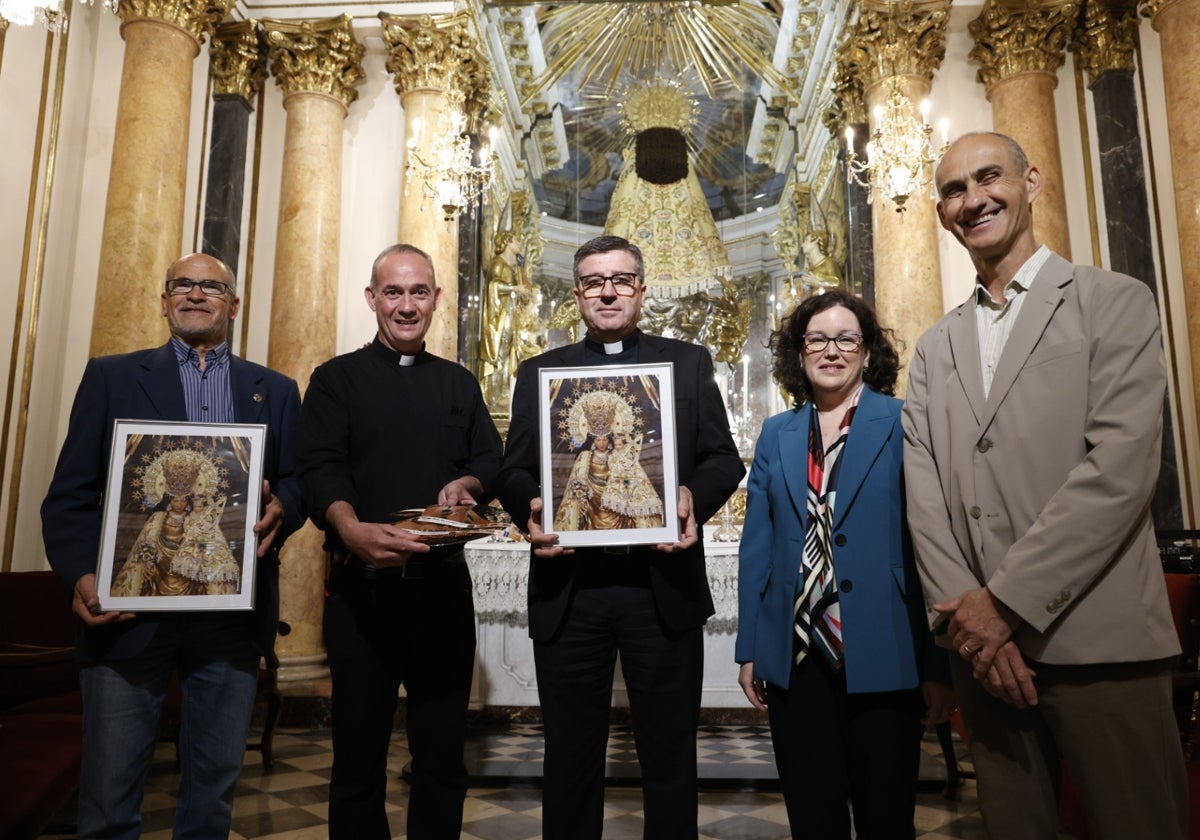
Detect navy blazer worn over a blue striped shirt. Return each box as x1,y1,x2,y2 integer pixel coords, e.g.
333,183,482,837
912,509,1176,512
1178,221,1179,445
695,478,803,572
42,343,304,660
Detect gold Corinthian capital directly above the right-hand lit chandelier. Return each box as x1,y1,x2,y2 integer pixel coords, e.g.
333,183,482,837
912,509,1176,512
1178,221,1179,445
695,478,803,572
838,0,950,90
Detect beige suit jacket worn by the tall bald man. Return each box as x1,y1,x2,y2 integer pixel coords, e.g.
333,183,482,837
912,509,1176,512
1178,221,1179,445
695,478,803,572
902,254,1180,664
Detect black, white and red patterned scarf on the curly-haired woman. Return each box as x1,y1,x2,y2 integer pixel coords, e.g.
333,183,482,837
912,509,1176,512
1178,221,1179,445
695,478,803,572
794,389,862,668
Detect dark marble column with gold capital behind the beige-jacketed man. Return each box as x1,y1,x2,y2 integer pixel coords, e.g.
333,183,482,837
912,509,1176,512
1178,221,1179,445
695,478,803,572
1075,4,1183,530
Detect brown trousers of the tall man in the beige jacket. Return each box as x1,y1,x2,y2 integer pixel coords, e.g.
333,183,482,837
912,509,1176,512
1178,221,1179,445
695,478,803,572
950,655,1188,840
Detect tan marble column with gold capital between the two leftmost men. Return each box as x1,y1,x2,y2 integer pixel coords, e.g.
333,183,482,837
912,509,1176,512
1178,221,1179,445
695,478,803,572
263,14,365,682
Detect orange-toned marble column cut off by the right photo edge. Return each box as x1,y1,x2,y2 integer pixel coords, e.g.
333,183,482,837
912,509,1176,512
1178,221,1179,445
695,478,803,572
1145,0,1200,482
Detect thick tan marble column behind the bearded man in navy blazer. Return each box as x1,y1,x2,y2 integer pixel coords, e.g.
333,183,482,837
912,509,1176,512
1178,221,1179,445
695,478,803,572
90,0,233,355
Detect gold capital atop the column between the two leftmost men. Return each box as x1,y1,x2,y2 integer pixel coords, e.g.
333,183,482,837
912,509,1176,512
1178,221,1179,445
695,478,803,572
263,14,366,108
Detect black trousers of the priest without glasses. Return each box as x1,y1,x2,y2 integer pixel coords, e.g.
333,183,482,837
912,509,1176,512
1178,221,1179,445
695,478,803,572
325,557,475,840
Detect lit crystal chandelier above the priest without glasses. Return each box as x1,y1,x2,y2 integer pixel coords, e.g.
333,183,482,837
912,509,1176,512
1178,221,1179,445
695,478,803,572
404,89,497,222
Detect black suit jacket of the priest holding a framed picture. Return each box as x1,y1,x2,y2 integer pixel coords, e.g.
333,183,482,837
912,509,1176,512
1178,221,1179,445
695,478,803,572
496,332,745,641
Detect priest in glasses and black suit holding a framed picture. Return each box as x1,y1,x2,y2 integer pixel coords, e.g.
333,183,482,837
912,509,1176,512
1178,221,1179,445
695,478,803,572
496,236,745,840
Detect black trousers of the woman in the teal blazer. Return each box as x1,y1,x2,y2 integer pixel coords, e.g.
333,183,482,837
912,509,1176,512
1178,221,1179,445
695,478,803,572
767,653,924,840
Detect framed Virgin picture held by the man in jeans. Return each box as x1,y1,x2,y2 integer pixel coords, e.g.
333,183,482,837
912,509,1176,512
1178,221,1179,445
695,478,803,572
96,420,266,612
